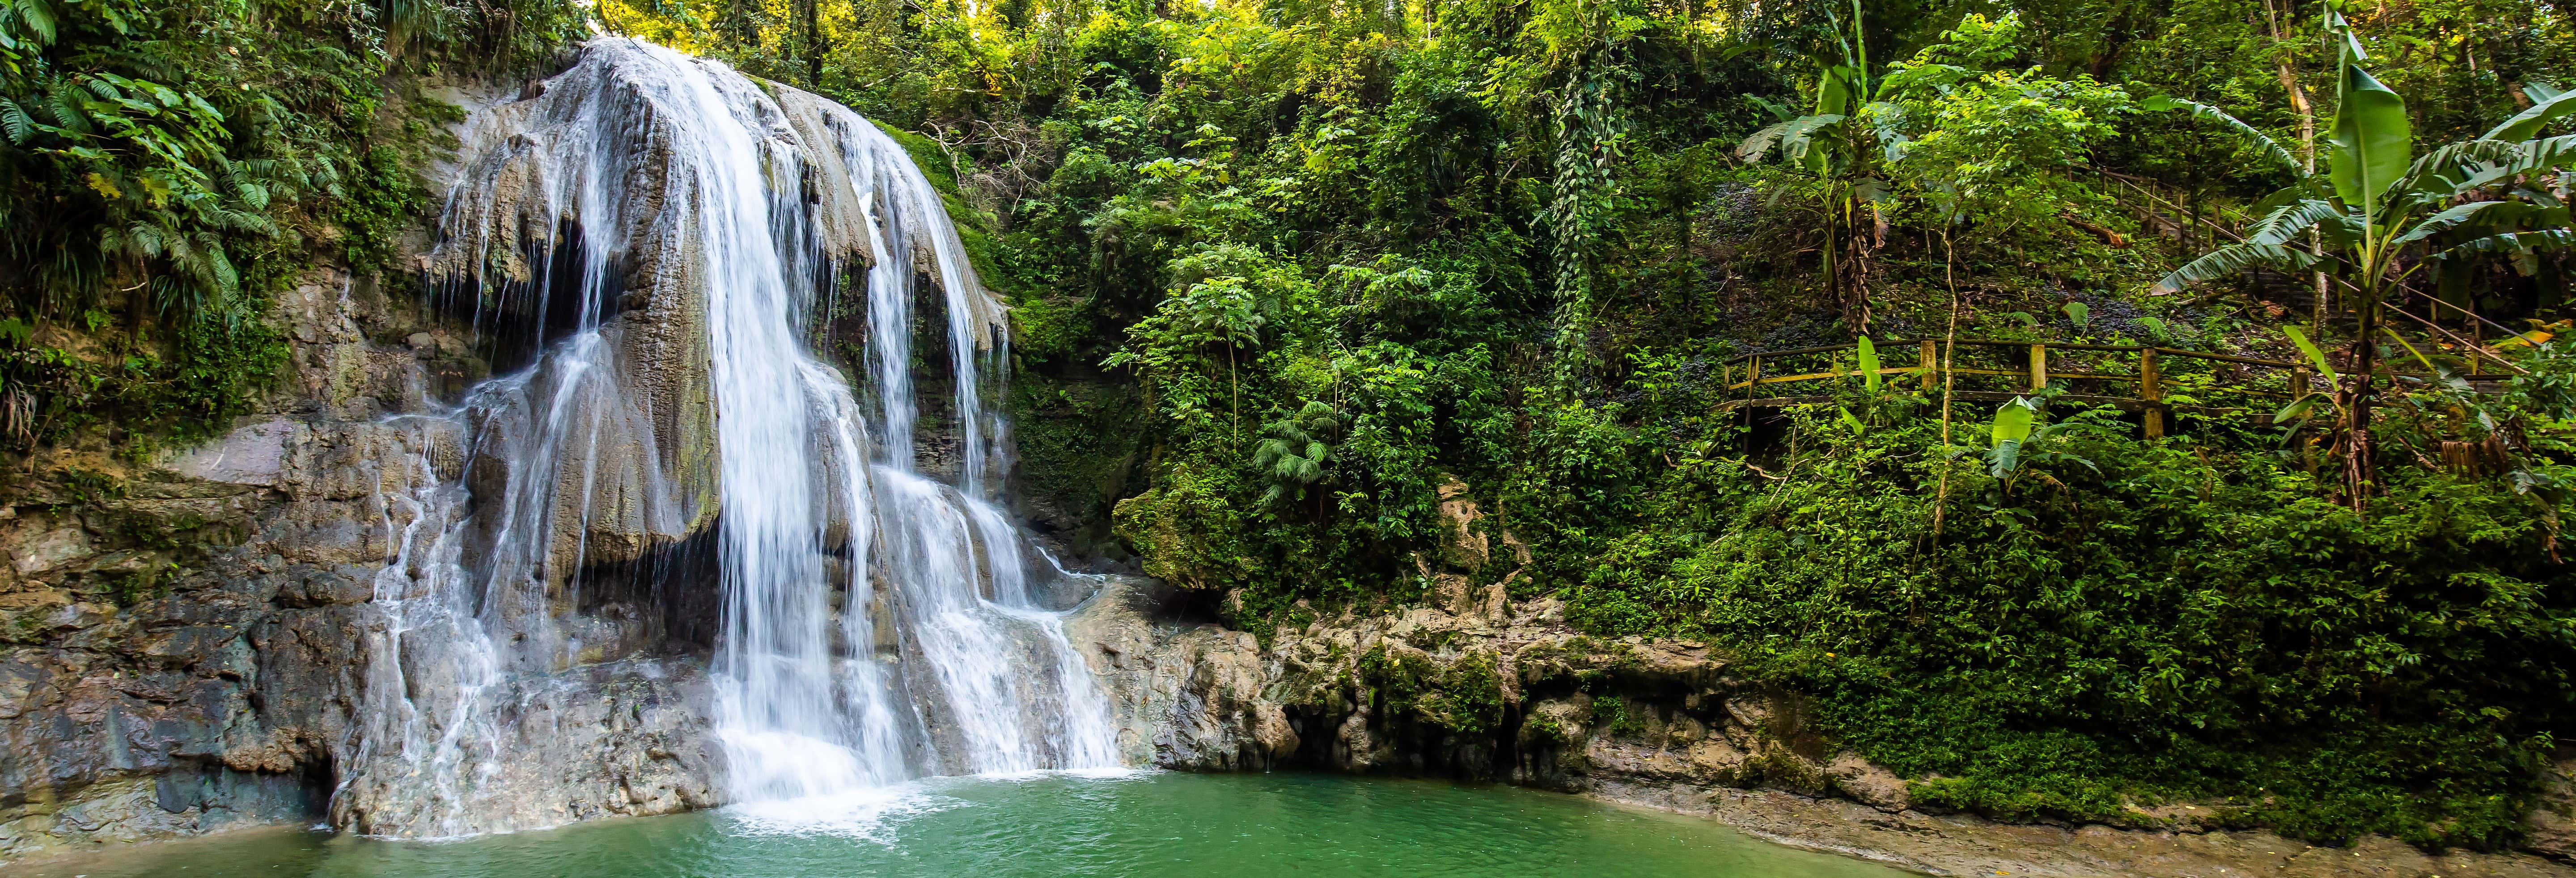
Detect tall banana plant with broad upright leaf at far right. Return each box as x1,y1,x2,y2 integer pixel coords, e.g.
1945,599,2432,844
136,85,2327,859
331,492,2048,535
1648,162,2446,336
2156,5,2576,510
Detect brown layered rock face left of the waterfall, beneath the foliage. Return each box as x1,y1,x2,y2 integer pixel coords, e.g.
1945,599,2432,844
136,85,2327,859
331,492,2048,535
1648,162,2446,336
0,270,482,857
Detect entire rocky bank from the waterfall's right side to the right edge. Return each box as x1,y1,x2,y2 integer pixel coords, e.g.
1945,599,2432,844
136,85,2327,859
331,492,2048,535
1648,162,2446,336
1069,577,2576,878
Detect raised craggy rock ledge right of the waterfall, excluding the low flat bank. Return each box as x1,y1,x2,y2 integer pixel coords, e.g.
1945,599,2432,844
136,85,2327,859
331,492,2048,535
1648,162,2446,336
1067,577,1906,811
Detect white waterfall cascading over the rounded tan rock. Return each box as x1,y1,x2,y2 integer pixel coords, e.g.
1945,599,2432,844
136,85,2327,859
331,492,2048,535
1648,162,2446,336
335,38,1118,837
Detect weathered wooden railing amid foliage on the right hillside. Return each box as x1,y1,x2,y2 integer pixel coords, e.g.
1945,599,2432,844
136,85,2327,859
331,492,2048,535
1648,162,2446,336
1718,337,2311,438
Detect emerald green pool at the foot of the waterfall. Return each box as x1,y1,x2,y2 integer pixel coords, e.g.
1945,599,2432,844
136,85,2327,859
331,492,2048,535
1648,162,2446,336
15,772,1901,878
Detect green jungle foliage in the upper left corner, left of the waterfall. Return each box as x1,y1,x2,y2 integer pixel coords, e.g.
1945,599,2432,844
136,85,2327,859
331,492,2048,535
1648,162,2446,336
0,0,585,451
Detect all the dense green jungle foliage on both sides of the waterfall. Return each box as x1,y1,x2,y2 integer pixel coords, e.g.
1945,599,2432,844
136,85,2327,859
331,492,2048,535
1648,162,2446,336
0,0,2576,847
